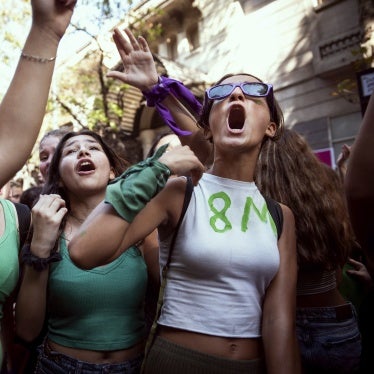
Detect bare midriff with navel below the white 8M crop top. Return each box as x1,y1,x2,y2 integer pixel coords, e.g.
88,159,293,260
158,326,264,360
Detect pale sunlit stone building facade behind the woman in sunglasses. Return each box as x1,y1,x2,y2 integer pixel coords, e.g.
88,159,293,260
125,0,374,166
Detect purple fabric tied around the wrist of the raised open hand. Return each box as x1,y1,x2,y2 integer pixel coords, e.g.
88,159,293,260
143,76,201,136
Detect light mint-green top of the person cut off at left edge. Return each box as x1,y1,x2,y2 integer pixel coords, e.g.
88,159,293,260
0,199,19,366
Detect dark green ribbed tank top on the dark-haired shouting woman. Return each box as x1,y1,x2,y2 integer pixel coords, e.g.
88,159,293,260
47,239,147,351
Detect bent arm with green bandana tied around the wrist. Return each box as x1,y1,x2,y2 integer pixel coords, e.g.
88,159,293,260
69,146,203,268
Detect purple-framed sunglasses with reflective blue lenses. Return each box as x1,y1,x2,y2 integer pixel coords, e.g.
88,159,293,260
206,82,273,100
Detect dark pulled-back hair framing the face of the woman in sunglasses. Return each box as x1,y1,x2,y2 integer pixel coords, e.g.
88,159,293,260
197,73,284,140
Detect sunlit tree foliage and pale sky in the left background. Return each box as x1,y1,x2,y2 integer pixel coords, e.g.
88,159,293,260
0,0,148,187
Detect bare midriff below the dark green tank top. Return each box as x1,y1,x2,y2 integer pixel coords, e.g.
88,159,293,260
46,339,145,364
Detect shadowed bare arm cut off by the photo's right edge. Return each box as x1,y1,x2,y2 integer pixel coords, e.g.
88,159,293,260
345,95,374,261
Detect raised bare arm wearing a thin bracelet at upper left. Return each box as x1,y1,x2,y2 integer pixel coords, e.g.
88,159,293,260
0,0,76,186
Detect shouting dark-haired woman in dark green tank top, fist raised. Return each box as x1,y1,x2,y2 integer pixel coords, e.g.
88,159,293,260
16,130,147,373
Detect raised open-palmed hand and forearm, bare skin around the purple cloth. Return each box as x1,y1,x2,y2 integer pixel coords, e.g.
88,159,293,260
108,28,212,164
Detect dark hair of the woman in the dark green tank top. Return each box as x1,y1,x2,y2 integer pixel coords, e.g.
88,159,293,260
42,130,129,235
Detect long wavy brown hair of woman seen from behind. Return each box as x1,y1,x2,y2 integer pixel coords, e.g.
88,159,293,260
255,129,357,270
